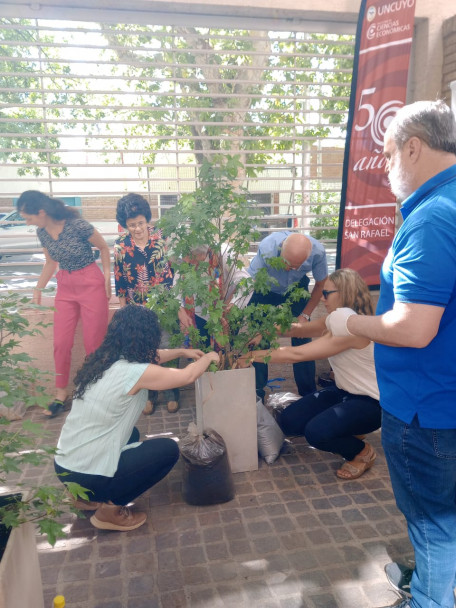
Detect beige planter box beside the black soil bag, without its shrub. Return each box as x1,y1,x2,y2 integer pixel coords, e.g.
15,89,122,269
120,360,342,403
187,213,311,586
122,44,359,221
195,367,258,473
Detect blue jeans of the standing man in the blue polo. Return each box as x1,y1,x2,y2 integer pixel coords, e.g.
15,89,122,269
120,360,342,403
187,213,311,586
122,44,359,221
382,410,456,608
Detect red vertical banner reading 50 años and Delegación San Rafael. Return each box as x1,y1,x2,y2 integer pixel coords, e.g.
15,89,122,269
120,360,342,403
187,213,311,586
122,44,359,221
336,0,415,286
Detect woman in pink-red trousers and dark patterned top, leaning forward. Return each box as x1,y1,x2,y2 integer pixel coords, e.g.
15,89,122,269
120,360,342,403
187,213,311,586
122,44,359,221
17,190,111,417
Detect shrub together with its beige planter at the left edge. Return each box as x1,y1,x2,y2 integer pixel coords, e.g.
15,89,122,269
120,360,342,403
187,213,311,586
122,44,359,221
0,291,87,608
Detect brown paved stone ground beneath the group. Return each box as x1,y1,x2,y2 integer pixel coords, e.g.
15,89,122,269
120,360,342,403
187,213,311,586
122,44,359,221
15,366,412,608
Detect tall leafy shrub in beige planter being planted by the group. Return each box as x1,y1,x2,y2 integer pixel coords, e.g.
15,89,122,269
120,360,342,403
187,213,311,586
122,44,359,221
148,156,304,472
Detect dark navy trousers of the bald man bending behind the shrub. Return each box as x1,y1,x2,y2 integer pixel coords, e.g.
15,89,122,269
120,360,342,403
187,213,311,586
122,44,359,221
249,276,316,399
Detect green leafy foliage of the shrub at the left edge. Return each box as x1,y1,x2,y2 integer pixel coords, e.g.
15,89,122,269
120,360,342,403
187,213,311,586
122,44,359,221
0,291,88,545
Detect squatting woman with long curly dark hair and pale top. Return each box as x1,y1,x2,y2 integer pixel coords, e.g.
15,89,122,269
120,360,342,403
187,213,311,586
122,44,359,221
55,306,218,530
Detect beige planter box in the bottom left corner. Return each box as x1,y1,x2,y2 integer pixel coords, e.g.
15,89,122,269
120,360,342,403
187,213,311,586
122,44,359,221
0,523,44,608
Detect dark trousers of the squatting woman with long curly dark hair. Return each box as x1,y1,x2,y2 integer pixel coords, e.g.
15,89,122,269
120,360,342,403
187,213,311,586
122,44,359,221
54,428,179,505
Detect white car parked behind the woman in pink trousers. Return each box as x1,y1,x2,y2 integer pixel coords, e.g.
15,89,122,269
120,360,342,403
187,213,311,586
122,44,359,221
0,210,123,258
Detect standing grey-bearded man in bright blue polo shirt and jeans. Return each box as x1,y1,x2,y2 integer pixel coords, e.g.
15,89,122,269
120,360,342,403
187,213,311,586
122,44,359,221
330,101,456,608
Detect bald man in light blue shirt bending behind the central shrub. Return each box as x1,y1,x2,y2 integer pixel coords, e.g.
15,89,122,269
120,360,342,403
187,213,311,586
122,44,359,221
248,231,328,399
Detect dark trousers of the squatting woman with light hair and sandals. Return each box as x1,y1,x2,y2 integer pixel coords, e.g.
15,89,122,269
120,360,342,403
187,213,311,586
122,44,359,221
280,386,381,460
